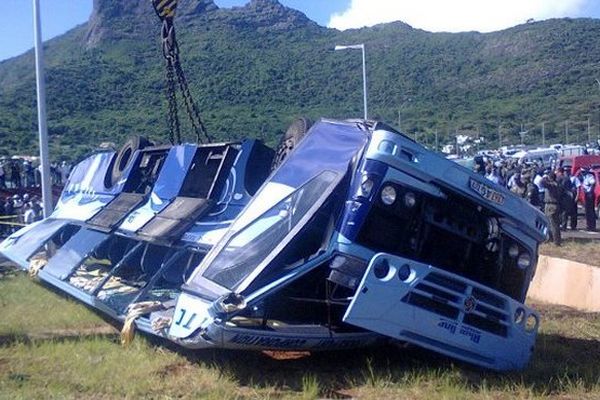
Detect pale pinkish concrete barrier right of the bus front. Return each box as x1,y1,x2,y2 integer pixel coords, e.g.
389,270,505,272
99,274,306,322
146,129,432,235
528,256,600,312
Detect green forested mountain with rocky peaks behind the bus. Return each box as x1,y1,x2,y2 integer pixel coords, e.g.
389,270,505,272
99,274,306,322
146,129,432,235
0,0,600,158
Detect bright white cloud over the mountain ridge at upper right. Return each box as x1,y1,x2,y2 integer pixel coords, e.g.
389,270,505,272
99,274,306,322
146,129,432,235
329,0,589,32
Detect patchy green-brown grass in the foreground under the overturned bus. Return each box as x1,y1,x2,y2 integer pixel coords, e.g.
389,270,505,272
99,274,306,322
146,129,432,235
0,271,600,399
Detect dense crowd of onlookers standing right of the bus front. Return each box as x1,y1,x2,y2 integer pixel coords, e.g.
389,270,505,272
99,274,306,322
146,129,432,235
474,157,600,246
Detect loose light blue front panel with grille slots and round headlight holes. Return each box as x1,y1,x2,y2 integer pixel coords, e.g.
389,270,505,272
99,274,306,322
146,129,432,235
343,254,539,370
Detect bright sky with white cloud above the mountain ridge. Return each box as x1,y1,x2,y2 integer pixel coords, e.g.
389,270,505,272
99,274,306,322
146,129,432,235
0,0,600,60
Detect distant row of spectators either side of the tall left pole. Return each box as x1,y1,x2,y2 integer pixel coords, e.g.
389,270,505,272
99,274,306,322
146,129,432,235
0,157,72,189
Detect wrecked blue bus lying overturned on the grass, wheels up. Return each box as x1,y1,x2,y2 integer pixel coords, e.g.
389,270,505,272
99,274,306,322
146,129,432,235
0,119,547,370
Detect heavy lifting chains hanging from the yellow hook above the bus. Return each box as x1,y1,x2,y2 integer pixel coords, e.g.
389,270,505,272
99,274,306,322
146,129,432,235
152,0,211,144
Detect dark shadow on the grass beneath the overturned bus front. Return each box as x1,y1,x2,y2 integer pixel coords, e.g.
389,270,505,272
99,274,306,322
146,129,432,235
165,334,600,398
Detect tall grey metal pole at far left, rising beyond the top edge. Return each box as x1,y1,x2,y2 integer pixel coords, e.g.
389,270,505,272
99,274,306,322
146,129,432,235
33,0,53,218
